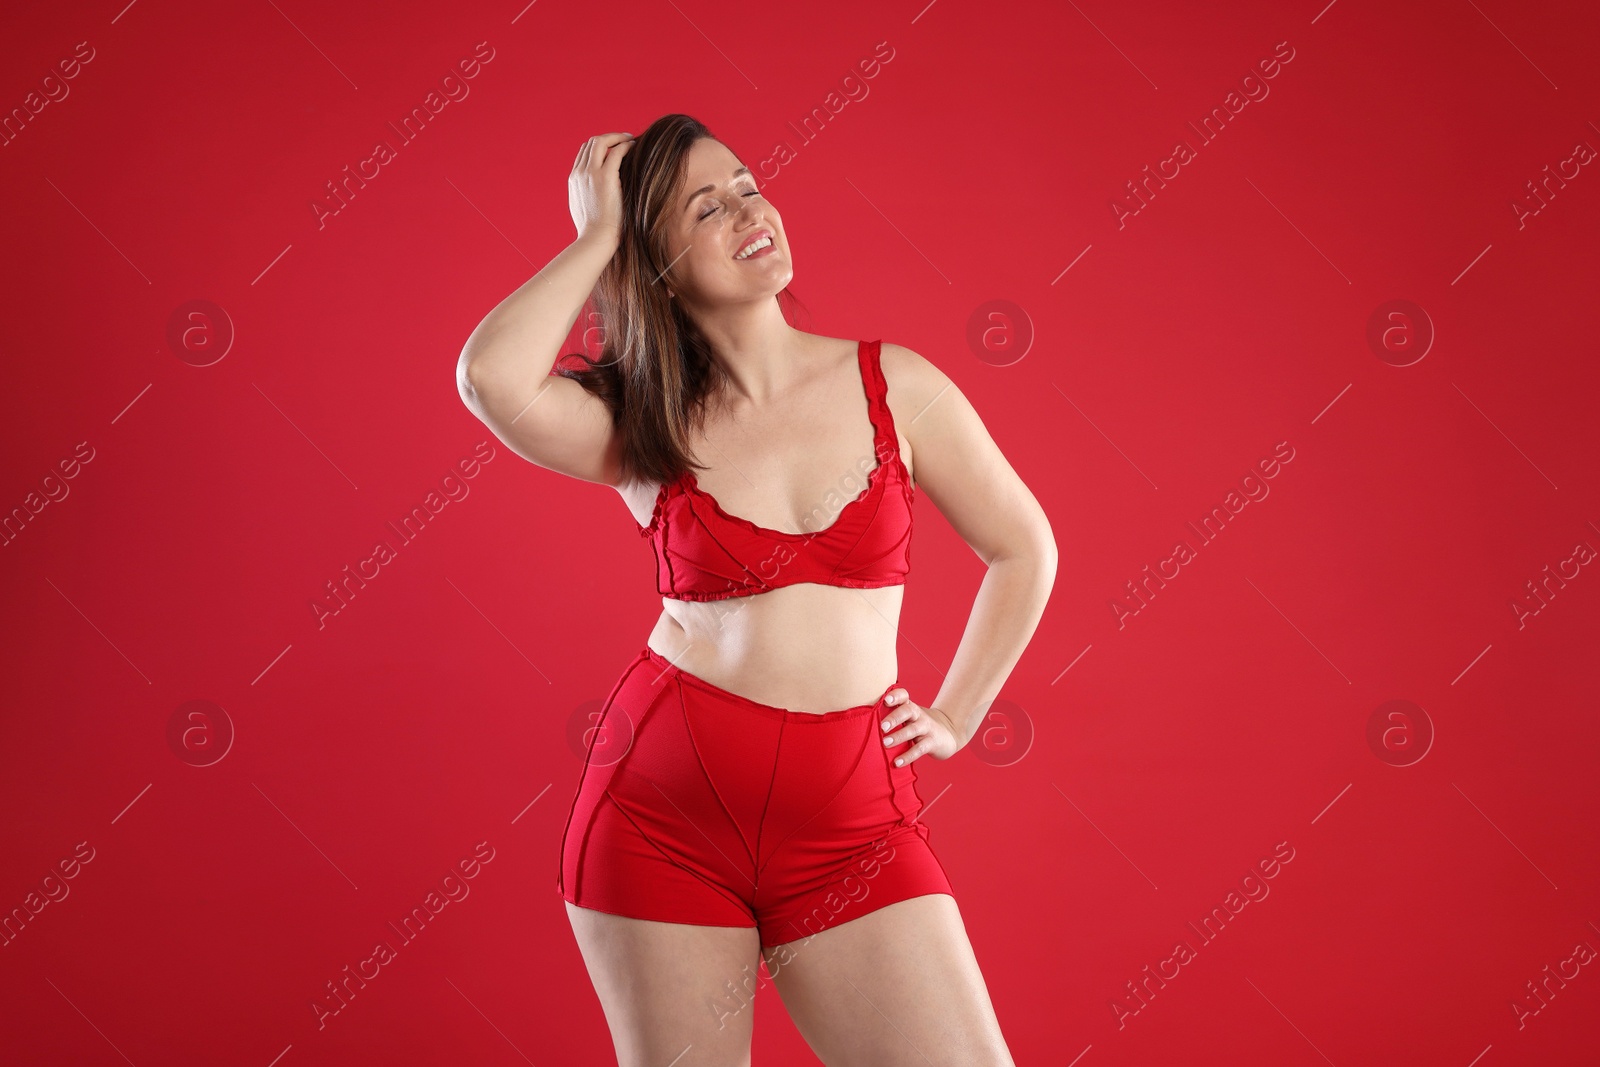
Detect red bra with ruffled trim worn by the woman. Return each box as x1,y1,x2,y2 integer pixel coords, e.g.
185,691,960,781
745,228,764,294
635,341,917,600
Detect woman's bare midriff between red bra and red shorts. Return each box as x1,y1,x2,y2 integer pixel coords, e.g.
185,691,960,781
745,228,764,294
646,582,906,713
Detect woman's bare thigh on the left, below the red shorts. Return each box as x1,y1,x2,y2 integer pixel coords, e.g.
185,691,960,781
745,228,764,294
566,902,762,1067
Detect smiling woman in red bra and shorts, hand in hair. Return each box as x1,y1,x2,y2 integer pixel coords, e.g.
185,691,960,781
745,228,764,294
458,115,1056,1067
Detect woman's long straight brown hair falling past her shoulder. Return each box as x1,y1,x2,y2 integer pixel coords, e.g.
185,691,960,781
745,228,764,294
555,115,803,482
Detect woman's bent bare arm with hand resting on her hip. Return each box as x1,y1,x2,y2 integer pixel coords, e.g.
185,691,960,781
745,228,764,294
882,344,1056,763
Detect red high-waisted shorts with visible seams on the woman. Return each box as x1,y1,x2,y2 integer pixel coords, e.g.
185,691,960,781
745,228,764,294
557,646,952,949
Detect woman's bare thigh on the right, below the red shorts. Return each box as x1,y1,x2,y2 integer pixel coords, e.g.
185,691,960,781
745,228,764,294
765,893,1014,1067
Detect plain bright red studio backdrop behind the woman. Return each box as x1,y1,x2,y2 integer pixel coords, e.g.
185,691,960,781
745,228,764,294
0,0,1600,1067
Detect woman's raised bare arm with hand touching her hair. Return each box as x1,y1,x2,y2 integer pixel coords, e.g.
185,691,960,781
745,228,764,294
456,133,632,485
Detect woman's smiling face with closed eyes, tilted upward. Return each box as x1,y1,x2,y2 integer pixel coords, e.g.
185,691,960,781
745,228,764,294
662,138,794,310
